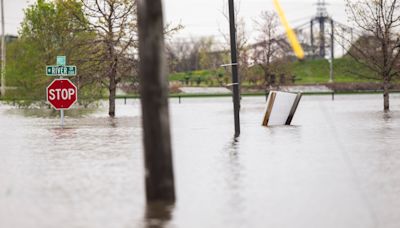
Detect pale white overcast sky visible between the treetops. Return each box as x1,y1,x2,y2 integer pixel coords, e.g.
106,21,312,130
4,0,347,38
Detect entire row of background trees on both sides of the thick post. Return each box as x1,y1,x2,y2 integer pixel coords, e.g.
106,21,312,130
6,0,400,113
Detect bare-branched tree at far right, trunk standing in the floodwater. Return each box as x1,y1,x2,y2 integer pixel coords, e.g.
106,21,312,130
346,0,400,111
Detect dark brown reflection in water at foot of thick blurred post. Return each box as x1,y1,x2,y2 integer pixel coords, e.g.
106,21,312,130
144,202,175,228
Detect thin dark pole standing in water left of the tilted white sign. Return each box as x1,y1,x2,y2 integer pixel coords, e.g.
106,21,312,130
228,0,240,137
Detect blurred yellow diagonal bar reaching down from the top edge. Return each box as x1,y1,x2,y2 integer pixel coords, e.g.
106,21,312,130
273,0,304,60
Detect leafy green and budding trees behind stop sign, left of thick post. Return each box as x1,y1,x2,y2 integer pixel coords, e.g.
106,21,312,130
6,0,179,117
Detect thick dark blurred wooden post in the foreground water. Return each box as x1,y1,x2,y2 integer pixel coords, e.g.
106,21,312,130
138,0,175,202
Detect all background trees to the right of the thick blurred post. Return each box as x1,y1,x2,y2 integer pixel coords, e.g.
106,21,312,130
165,0,400,111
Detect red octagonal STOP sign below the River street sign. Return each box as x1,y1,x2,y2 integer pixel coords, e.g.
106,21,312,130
46,79,78,110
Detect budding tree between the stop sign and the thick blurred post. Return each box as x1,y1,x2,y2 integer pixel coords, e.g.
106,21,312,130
76,0,137,117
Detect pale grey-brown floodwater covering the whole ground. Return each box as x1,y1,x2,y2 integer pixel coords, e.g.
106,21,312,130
0,94,400,228
